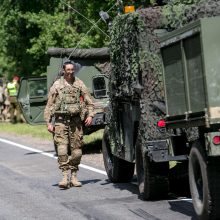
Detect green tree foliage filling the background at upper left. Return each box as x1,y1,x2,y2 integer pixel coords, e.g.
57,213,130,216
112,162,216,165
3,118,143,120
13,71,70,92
0,0,116,79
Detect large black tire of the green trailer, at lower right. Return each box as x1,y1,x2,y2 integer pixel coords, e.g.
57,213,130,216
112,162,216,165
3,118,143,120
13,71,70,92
189,141,220,220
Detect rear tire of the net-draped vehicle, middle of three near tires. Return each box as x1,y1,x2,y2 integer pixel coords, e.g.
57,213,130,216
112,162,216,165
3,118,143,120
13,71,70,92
136,141,169,200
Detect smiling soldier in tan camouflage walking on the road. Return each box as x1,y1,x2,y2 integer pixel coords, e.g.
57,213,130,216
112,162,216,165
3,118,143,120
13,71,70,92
44,61,94,188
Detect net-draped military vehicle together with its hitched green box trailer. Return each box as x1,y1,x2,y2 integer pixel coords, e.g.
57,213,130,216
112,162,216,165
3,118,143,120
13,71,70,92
93,1,220,219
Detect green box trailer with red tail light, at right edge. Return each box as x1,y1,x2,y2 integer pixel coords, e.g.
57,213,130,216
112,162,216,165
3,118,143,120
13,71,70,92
159,17,220,219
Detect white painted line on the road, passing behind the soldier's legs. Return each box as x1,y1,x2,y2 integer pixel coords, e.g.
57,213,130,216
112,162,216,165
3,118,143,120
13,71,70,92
0,138,107,175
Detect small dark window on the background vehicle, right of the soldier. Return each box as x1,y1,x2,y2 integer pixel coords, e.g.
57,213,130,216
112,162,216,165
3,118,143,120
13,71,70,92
92,75,108,99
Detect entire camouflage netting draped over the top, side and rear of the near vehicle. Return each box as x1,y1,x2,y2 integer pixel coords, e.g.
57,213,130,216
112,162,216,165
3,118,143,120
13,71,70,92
109,0,220,148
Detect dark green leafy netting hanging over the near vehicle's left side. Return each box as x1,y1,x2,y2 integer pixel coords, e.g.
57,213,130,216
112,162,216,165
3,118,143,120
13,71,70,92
110,13,143,97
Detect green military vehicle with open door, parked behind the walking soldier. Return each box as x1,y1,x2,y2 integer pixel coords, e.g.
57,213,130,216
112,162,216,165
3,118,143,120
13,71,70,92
18,48,109,152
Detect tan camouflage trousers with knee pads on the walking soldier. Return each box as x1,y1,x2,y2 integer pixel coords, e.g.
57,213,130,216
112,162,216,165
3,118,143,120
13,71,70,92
54,116,83,171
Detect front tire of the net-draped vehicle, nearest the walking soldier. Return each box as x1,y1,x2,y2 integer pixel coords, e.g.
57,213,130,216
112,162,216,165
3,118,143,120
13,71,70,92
102,128,135,183
